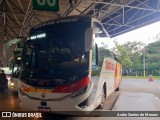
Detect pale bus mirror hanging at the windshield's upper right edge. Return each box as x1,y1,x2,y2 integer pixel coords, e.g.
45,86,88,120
85,28,93,51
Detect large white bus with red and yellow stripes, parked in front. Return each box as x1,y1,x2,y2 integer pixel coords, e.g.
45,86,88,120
18,16,122,112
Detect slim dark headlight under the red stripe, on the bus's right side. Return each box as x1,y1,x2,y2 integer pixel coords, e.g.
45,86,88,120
70,83,91,98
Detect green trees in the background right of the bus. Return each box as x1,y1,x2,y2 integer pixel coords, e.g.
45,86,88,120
116,34,160,75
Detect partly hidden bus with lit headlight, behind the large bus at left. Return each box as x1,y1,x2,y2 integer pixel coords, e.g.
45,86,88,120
3,37,26,92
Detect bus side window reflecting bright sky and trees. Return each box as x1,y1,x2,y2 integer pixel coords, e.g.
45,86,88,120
93,22,119,64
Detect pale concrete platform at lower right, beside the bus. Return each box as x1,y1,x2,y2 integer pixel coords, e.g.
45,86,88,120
112,92,160,111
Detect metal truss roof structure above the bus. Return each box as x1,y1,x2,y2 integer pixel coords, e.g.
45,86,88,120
0,0,160,64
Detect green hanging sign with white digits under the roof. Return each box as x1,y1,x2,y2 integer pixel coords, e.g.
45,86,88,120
32,0,59,12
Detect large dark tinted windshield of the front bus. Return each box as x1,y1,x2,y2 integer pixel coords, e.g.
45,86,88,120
24,22,89,86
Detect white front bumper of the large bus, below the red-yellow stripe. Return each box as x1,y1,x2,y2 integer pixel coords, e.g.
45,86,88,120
18,84,95,114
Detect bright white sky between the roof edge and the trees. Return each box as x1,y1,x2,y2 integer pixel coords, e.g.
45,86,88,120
112,21,160,45
